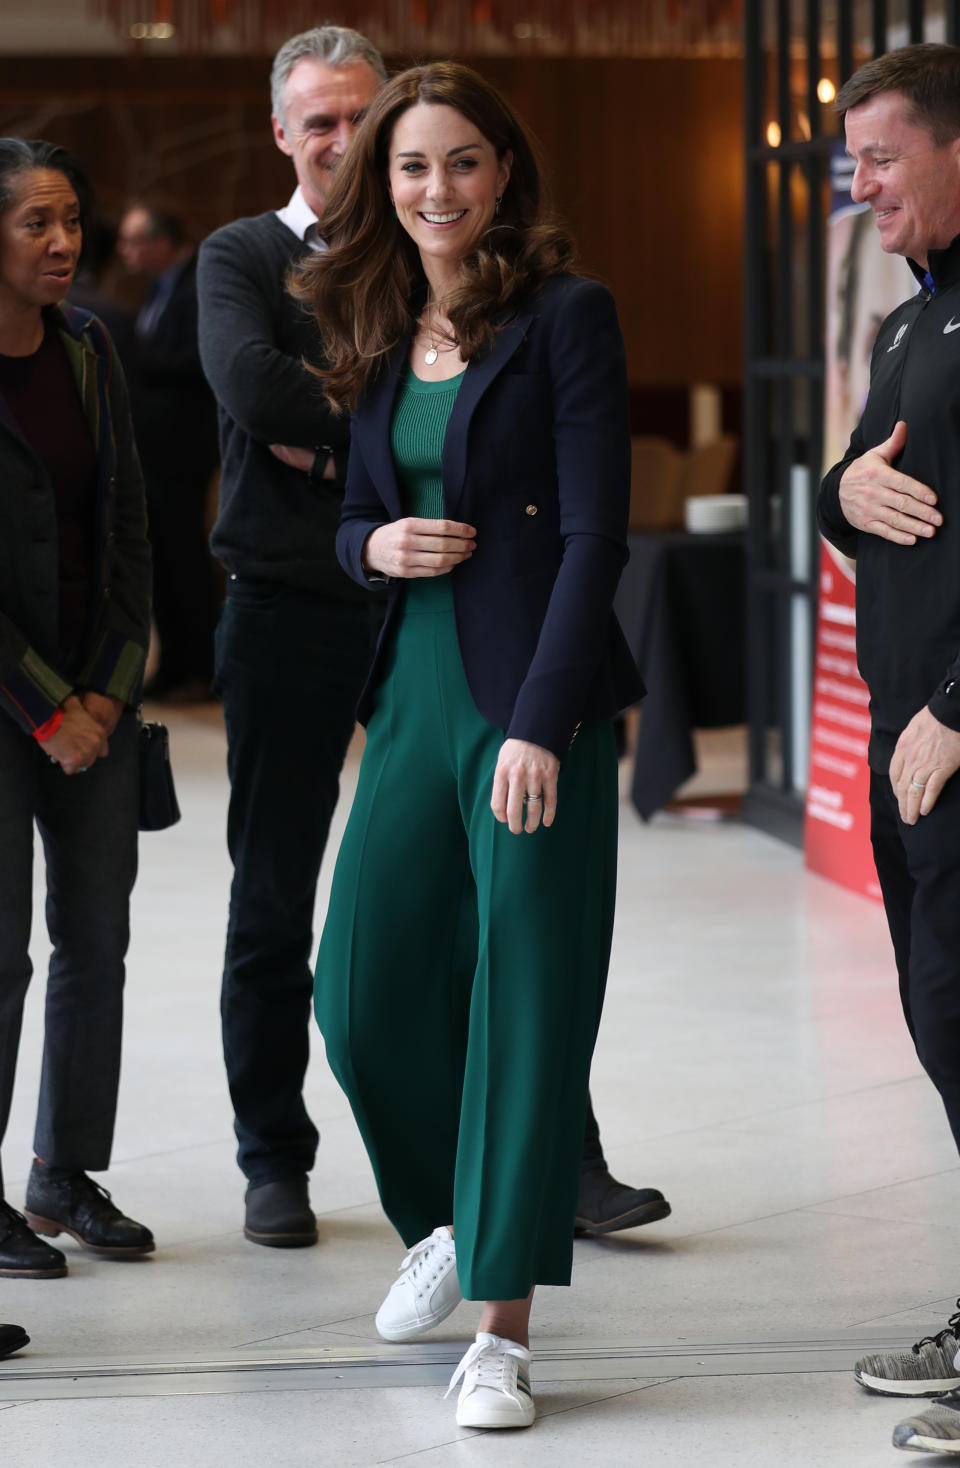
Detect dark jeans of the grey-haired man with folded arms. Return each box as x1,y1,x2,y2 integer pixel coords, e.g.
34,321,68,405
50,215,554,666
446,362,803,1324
214,577,380,1185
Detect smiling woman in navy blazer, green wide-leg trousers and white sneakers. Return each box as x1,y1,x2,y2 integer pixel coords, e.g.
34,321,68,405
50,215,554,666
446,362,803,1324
302,63,641,1427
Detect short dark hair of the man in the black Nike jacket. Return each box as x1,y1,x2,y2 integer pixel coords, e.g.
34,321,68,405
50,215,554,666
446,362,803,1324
834,41,960,147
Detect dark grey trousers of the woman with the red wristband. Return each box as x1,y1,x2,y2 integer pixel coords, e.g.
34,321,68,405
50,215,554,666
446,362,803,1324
0,712,138,1193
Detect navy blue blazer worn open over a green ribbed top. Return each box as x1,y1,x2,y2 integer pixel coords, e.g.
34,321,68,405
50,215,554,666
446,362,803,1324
336,275,644,759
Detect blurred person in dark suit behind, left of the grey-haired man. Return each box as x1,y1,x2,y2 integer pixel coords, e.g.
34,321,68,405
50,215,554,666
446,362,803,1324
117,204,217,703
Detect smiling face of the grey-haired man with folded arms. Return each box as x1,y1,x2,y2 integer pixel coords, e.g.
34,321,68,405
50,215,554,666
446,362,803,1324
272,56,380,214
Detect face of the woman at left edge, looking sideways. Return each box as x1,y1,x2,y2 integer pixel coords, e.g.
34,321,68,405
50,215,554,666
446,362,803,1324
0,169,82,311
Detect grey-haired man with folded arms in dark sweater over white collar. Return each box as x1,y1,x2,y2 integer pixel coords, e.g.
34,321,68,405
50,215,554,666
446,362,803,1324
198,26,386,1248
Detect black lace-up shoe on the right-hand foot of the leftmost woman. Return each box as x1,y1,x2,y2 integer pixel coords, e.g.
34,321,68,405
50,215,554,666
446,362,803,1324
23,1158,156,1260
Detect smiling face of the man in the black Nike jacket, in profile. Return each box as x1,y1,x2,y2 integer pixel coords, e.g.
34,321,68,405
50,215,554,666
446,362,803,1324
846,91,960,269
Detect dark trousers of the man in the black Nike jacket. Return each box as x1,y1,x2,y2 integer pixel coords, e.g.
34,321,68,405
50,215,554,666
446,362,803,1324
870,772,960,1148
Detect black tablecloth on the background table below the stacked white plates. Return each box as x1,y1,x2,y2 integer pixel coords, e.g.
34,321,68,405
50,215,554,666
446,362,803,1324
615,531,746,821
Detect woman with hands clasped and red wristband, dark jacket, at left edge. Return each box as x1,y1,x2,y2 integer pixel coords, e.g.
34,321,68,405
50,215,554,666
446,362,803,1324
0,138,154,1277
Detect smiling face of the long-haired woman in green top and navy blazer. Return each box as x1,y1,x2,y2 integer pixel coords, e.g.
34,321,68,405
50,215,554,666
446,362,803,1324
389,103,512,291
